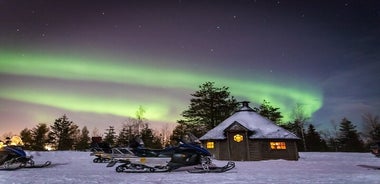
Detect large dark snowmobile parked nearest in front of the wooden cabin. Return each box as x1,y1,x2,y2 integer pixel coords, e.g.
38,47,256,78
107,135,235,173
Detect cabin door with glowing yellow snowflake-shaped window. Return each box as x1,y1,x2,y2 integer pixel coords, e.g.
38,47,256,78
228,131,248,161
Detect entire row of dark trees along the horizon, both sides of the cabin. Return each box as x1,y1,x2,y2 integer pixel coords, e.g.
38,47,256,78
8,82,380,152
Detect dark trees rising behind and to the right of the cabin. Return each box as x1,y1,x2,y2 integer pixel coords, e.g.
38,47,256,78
172,82,380,152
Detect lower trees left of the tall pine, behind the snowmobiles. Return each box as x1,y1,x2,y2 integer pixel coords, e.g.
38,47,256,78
20,112,168,151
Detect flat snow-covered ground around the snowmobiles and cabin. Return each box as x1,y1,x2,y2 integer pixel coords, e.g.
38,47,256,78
0,151,380,184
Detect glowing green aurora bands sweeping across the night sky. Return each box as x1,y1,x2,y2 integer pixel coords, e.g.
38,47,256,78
0,51,323,122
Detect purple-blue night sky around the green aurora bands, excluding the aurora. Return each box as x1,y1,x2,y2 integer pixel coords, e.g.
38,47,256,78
0,0,380,135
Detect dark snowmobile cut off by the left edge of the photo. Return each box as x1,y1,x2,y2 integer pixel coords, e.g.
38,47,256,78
0,146,51,170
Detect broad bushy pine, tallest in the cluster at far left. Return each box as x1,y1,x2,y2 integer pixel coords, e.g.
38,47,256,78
49,115,78,150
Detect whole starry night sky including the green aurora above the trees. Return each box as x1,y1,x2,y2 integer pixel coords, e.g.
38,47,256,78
0,0,380,135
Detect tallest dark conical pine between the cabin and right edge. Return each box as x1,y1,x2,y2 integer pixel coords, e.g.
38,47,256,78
338,118,363,152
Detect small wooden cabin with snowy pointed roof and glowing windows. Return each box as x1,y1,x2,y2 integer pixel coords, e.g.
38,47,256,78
200,102,299,161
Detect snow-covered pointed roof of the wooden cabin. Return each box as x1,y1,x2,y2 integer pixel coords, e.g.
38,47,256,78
200,102,299,140
